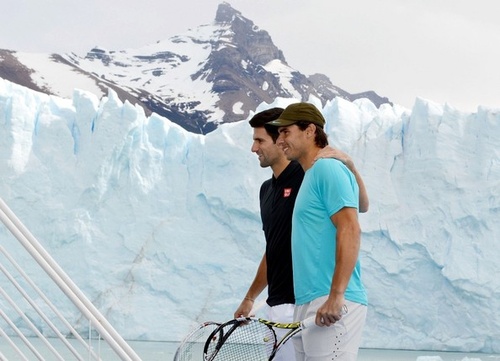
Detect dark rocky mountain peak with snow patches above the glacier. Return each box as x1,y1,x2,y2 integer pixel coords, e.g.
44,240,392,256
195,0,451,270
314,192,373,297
0,3,389,134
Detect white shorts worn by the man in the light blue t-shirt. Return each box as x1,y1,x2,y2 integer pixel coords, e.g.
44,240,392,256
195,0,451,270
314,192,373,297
292,296,367,361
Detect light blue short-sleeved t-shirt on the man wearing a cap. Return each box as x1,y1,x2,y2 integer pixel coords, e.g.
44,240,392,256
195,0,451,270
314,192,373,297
292,159,367,305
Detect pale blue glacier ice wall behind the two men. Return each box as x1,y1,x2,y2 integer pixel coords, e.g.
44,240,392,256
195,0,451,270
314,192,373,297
0,72,500,353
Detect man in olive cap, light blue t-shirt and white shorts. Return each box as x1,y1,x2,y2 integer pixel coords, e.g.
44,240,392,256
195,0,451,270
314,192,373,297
268,103,367,361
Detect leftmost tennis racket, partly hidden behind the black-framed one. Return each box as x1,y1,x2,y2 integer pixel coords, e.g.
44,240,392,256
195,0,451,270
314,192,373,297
174,322,221,361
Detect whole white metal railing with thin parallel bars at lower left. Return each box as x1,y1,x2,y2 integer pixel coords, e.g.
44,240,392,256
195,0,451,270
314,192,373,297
0,198,140,361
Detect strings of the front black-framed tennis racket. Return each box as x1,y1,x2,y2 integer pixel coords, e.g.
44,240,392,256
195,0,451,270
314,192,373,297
208,320,276,361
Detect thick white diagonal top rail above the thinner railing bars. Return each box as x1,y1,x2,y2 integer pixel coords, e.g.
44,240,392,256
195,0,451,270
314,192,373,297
0,198,141,361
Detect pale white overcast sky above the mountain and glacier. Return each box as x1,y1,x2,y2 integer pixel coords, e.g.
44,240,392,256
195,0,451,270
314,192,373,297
0,0,500,111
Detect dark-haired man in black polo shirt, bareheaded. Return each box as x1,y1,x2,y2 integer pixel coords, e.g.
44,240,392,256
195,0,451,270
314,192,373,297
234,108,368,361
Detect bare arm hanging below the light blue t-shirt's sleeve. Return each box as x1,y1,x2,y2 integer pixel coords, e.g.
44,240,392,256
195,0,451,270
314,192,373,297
316,207,361,326
